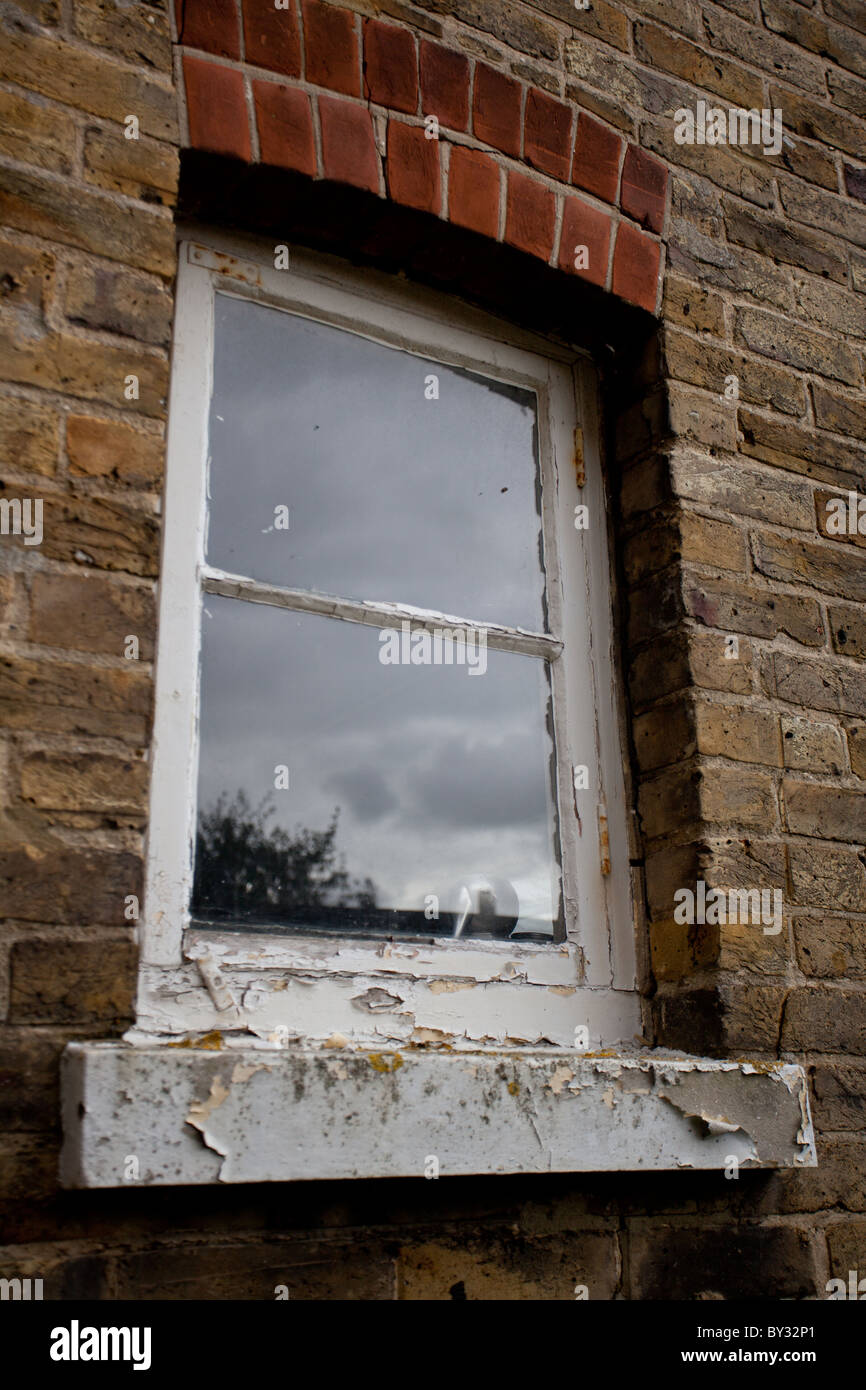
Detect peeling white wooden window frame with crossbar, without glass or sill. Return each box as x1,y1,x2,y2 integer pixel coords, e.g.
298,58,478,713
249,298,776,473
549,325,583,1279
128,232,641,1051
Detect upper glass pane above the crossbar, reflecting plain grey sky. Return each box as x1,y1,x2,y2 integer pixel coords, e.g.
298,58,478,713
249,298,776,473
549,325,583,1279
207,295,546,631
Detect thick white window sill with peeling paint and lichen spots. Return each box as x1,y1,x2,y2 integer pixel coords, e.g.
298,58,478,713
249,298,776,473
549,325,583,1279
61,1043,816,1187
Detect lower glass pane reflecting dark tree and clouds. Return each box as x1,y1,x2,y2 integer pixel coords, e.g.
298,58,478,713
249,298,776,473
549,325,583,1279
193,594,559,940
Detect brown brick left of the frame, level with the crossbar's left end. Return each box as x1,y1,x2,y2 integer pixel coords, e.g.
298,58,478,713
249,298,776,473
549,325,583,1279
28,573,156,658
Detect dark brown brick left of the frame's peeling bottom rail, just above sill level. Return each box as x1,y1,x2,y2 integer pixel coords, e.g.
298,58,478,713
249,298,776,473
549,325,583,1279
10,934,138,1023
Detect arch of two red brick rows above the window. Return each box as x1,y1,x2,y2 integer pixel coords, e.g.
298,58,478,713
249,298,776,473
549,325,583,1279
177,0,667,313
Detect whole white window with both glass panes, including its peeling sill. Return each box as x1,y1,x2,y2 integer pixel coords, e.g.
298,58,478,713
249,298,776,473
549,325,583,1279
61,236,815,1187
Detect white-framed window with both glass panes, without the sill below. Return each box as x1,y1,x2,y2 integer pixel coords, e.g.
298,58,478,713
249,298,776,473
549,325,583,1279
139,238,639,1049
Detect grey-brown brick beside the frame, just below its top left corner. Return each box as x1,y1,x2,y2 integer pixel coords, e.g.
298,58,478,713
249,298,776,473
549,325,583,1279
65,265,174,346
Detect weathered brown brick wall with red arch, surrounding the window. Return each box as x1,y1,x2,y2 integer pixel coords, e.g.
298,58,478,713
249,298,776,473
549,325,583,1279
0,0,866,1298
